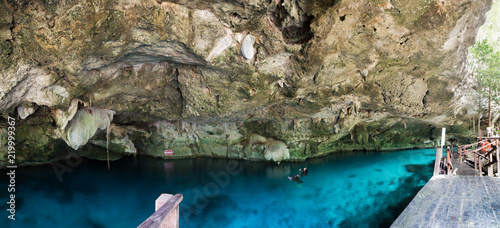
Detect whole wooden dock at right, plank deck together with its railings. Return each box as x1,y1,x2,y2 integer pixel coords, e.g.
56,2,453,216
391,143,500,228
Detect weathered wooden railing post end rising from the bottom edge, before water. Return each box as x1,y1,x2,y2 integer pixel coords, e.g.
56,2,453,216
138,194,183,228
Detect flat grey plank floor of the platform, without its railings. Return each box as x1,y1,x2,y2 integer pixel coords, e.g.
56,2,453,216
391,175,500,228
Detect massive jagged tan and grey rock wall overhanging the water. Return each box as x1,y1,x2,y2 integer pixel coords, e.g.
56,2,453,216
0,0,491,165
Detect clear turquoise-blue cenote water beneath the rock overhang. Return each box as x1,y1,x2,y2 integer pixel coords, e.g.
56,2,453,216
0,150,435,227
